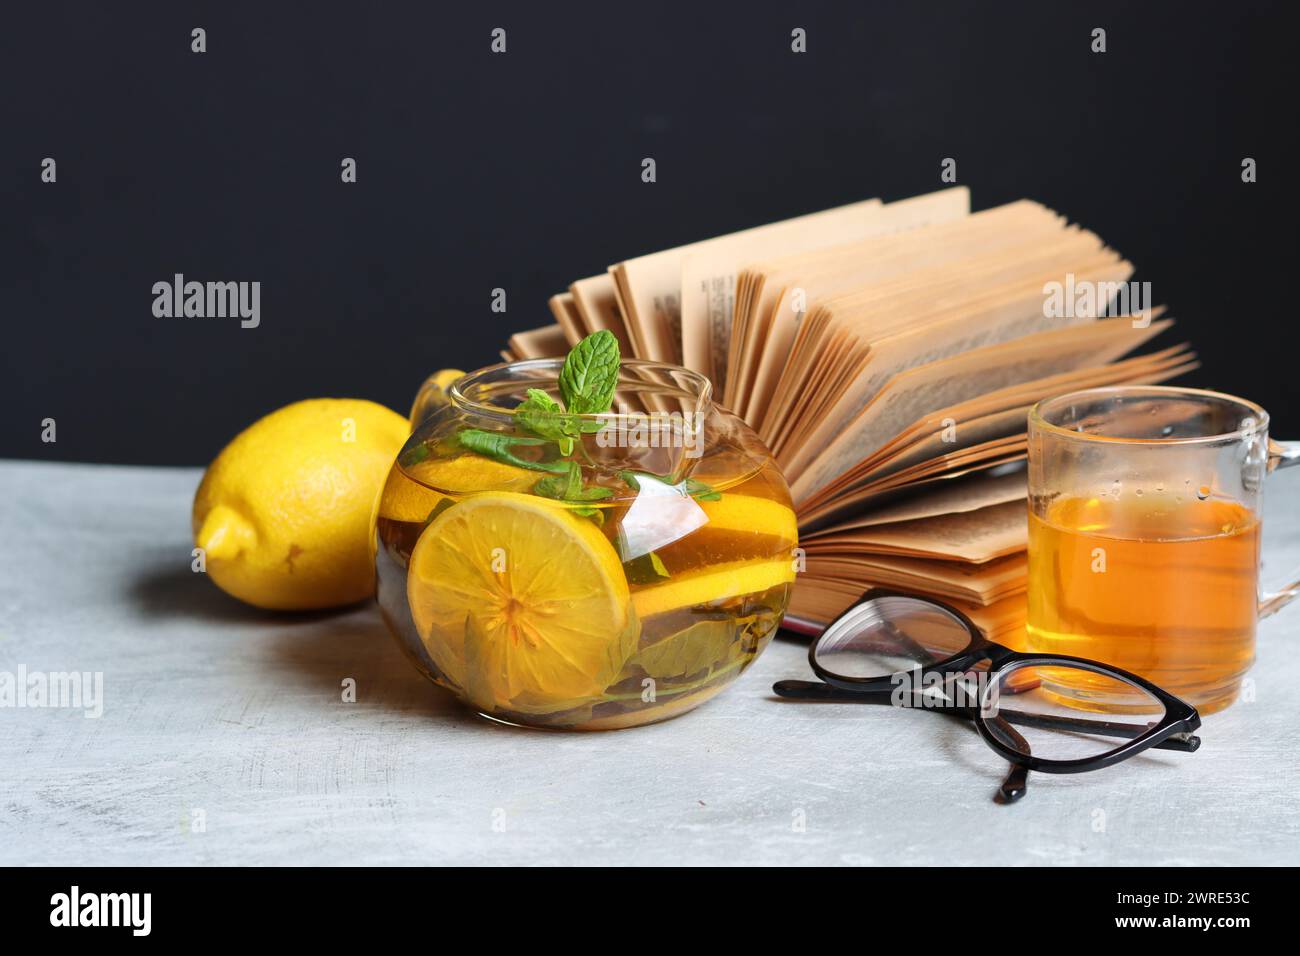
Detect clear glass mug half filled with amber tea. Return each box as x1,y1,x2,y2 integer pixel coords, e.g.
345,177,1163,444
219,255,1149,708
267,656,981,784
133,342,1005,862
1027,386,1300,714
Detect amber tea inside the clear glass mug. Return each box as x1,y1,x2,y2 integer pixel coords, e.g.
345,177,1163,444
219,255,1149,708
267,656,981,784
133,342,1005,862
1028,492,1260,714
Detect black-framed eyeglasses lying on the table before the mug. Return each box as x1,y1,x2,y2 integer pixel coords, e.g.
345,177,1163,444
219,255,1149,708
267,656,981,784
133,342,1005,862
772,588,1201,803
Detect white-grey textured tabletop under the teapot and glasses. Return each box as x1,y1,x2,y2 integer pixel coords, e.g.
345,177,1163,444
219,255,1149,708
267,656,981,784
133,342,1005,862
0,462,1300,865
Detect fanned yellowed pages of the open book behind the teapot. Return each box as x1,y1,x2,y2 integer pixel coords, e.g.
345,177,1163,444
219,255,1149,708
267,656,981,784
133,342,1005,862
502,187,1196,637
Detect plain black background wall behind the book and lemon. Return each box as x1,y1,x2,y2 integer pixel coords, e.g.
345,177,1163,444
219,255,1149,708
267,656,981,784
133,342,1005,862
0,3,1300,464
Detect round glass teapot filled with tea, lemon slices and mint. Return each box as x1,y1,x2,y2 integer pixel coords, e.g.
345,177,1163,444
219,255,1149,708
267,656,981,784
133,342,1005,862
373,359,797,730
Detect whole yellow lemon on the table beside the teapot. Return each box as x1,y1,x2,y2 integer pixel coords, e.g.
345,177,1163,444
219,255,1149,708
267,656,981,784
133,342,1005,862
194,398,410,610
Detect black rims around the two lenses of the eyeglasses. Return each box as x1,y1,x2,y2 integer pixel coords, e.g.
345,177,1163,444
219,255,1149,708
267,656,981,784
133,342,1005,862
809,588,1201,774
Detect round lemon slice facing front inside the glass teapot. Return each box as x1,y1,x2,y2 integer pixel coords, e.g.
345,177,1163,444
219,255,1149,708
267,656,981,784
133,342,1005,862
407,492,640,713
